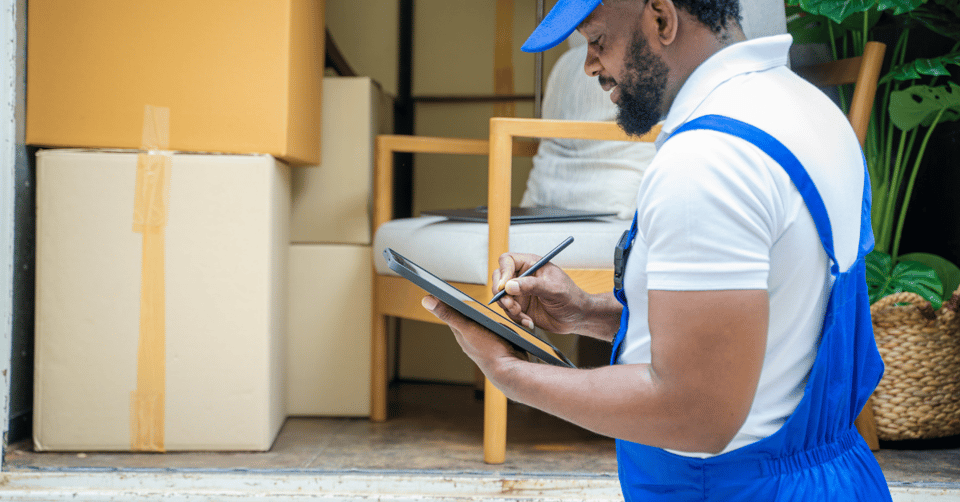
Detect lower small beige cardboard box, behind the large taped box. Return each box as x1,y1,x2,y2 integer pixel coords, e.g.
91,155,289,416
286,244,373,416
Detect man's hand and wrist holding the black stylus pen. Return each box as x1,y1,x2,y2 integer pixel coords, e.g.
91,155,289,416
493,253,621,341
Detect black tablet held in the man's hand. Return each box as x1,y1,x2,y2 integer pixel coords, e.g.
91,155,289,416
383,248,576,368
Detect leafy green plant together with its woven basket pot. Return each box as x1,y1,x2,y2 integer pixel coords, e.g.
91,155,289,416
787,0,960,441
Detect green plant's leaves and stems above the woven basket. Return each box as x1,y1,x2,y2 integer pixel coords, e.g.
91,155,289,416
787,0,960,309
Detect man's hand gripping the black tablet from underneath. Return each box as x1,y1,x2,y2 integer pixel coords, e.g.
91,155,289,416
421,296,526,376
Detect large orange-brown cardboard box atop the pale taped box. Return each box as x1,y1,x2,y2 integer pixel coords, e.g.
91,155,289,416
26,0,324,164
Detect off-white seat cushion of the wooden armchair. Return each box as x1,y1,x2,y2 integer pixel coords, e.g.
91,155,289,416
373,216,630,288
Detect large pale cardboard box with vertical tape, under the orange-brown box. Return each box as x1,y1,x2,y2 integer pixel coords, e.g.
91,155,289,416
33,150,290,451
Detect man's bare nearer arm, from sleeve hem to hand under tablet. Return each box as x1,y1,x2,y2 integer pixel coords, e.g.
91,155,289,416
424,290,768,453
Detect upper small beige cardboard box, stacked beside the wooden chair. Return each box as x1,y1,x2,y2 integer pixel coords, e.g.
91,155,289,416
290,77,393,244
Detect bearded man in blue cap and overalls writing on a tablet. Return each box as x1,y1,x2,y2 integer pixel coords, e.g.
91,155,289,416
423,0,890,500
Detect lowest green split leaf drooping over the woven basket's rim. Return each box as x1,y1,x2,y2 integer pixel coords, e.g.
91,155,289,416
867,251,943,309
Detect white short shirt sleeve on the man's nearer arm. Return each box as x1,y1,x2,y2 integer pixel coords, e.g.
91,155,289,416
637,131,783,291
